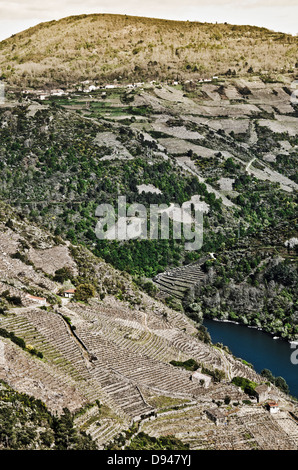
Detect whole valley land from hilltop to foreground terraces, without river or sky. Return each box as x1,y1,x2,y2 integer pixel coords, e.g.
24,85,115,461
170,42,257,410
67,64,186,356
0,11,298,450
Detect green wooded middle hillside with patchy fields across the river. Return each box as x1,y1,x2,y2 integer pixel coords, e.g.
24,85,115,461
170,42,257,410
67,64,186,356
0,75,298,339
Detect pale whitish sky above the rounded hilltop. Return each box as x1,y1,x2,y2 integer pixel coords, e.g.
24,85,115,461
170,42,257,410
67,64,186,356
0,0,298,40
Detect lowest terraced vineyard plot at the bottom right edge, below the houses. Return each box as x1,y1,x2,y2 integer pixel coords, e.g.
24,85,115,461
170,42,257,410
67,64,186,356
142,404,297,450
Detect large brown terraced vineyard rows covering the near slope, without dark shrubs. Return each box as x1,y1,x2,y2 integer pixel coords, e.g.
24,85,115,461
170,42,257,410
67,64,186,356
0,211,296,448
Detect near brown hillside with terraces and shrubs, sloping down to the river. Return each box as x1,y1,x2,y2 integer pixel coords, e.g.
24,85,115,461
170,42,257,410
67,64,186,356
0,200,297,449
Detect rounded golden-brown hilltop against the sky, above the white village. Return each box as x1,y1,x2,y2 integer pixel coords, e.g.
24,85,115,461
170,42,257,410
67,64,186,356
0,14,298,86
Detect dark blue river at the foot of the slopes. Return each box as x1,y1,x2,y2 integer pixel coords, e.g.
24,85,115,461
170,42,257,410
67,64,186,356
203,319,298,398
